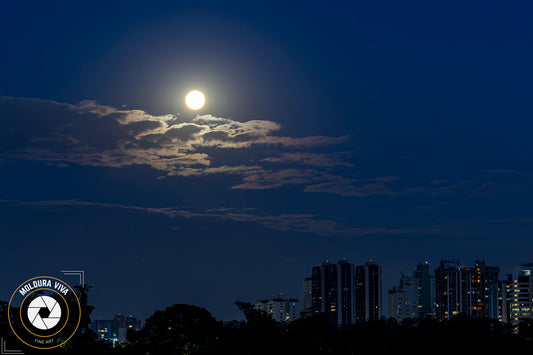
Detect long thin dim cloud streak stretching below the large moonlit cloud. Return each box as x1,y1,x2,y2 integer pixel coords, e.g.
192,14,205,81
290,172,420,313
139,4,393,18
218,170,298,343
4,200,533,239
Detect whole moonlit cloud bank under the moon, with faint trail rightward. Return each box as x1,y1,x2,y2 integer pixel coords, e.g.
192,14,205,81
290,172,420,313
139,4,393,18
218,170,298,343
0,96,530,198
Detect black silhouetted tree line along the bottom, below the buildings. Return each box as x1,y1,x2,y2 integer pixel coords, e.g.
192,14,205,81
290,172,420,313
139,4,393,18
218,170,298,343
0,287,533,355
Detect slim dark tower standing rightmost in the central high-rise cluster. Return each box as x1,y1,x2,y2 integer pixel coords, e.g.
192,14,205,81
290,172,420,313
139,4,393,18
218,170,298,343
355,260,383,323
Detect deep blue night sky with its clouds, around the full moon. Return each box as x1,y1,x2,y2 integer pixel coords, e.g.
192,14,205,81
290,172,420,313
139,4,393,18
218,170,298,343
0,1,533,320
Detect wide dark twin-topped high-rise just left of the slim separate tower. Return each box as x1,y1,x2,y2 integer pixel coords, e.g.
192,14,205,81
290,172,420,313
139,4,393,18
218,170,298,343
304,259,355,325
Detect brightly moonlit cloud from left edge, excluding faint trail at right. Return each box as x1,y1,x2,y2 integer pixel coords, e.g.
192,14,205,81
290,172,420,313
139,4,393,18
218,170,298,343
0,97,353,195
